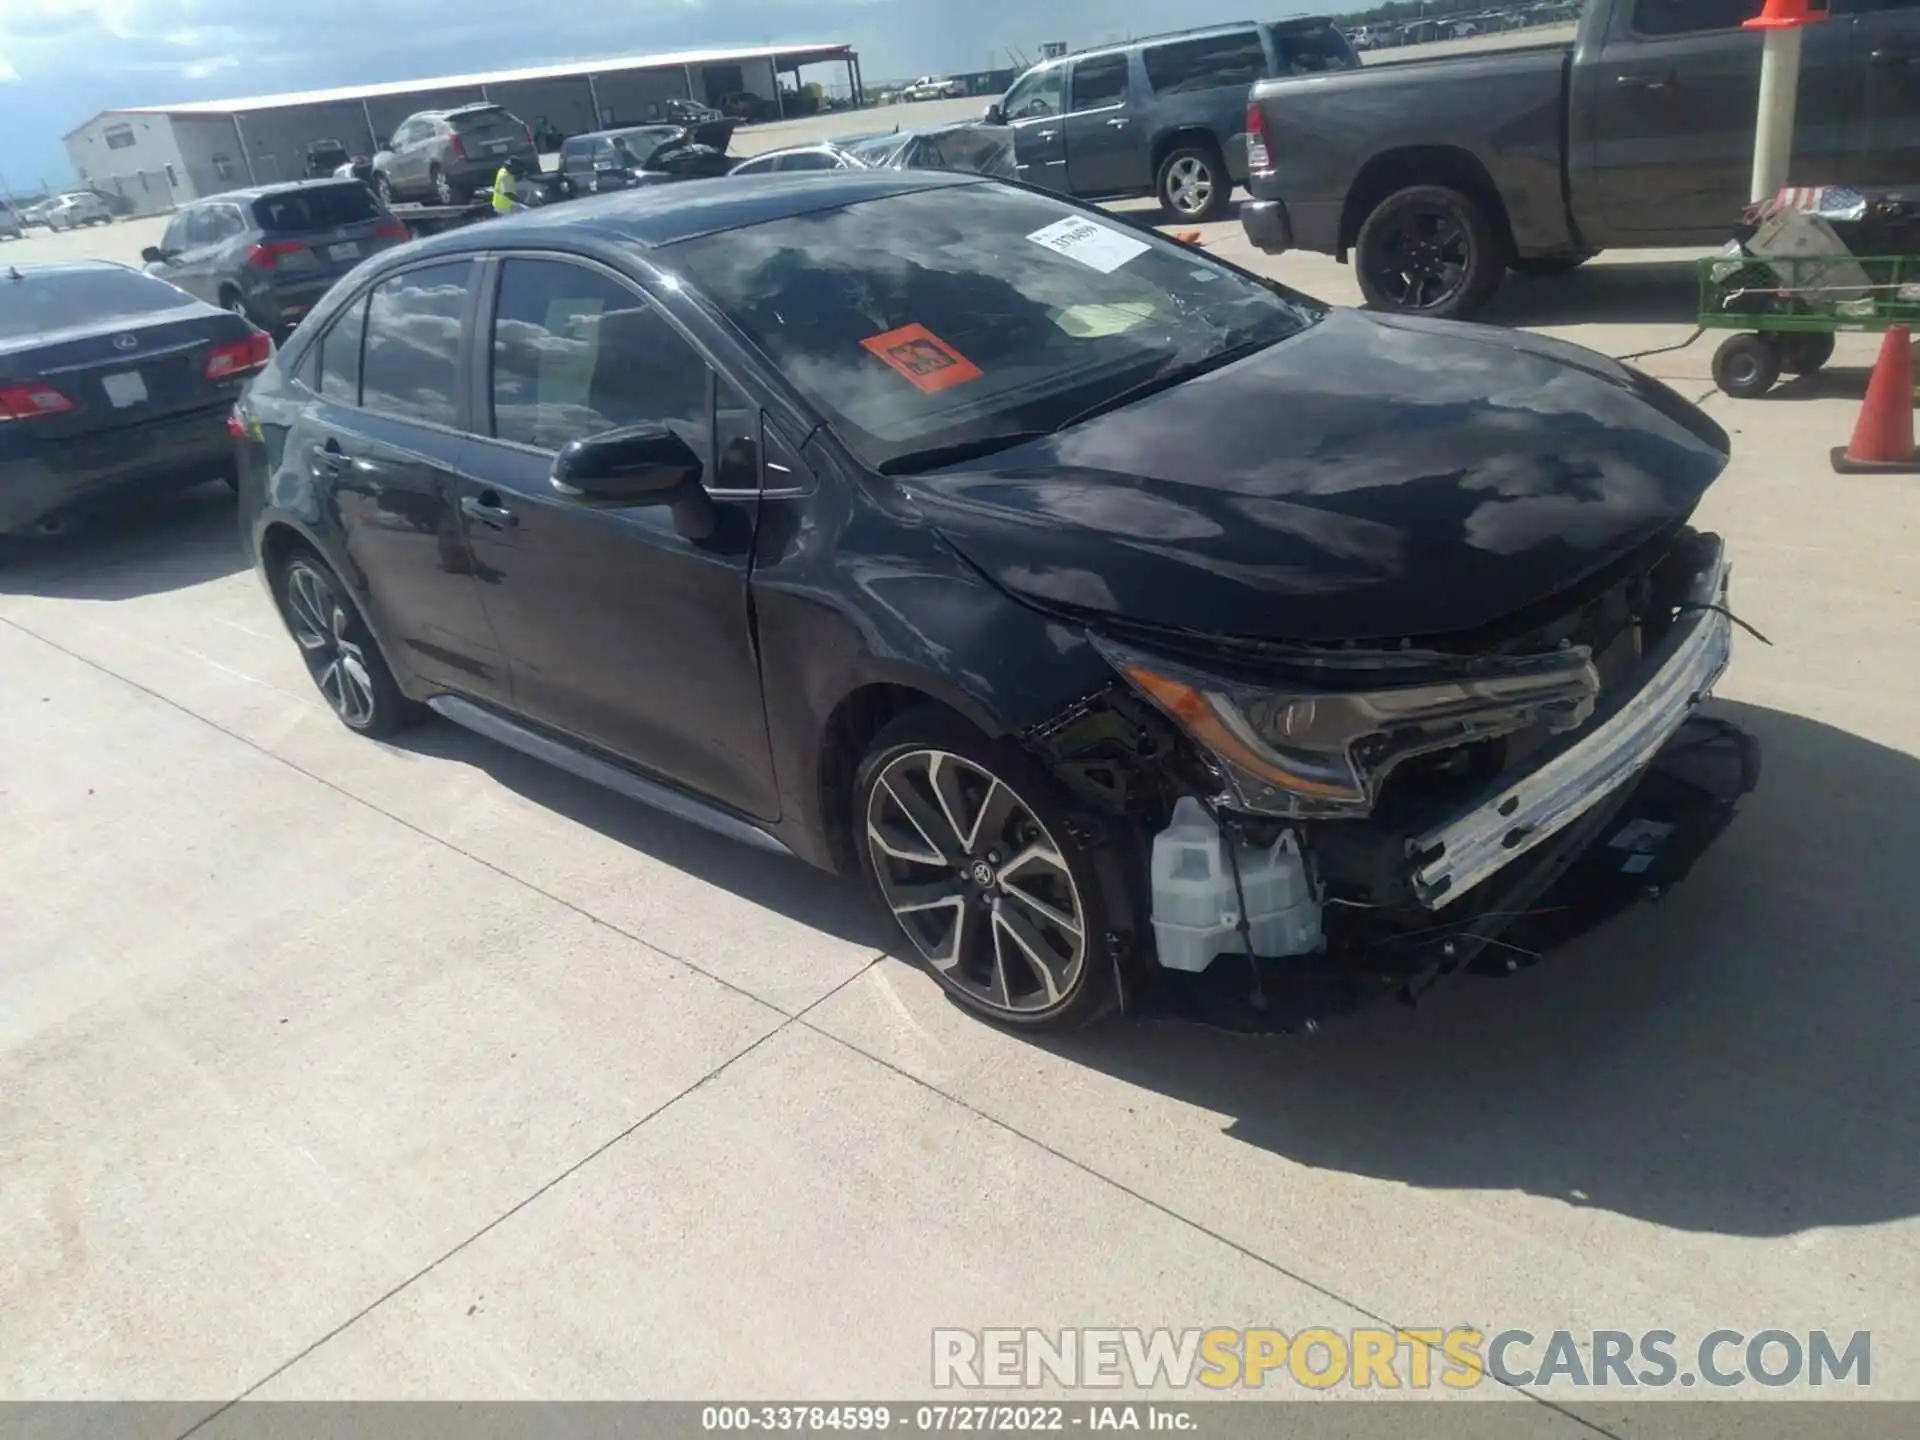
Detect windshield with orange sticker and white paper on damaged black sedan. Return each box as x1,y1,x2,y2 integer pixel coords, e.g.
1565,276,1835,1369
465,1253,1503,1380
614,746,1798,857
662,182,1323,468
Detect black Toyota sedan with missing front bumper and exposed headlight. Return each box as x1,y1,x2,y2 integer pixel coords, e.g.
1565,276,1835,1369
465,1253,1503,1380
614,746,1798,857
228,171,1757,1027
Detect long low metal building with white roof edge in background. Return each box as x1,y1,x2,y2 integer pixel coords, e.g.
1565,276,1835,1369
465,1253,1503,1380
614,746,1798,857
65,44,860,213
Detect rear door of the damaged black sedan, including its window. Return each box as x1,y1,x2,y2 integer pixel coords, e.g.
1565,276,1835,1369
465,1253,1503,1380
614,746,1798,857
292,259,509,703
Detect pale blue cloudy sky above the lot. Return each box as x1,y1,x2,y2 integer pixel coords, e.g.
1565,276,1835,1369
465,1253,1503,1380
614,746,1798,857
0,0,1308,190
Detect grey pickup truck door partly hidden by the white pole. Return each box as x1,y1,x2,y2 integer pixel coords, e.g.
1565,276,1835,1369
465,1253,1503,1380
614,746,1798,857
1574,0,1859,244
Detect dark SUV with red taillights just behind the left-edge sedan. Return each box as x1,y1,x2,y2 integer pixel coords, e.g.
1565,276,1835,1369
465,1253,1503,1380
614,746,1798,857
140,180,407,332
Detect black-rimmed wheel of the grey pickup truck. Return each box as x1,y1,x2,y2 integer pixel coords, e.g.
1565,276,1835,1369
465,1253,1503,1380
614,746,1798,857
1354,184,1509,319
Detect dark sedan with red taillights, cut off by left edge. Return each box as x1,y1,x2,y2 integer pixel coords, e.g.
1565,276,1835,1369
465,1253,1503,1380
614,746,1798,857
0,261,273,536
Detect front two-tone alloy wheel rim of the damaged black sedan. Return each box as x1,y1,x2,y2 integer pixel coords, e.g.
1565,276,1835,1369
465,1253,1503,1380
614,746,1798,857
866,749,1087,1014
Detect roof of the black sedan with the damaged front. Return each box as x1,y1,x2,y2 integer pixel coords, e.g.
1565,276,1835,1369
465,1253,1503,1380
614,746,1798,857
399,168,991,257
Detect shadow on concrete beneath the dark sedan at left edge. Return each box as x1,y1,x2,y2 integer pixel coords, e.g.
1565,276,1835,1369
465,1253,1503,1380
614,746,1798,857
0,482,248,601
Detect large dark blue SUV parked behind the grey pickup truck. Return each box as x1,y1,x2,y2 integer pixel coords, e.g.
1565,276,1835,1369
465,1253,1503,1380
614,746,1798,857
987,15,1359,221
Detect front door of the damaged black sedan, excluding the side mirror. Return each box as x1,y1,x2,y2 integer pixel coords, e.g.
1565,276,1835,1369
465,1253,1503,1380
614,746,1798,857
451,259,780,820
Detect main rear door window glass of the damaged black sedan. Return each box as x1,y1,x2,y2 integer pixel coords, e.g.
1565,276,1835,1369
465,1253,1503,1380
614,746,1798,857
361,259,472,428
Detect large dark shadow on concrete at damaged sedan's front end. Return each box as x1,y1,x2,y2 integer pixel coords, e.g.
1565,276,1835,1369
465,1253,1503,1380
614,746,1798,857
1050,705,1920,1236
